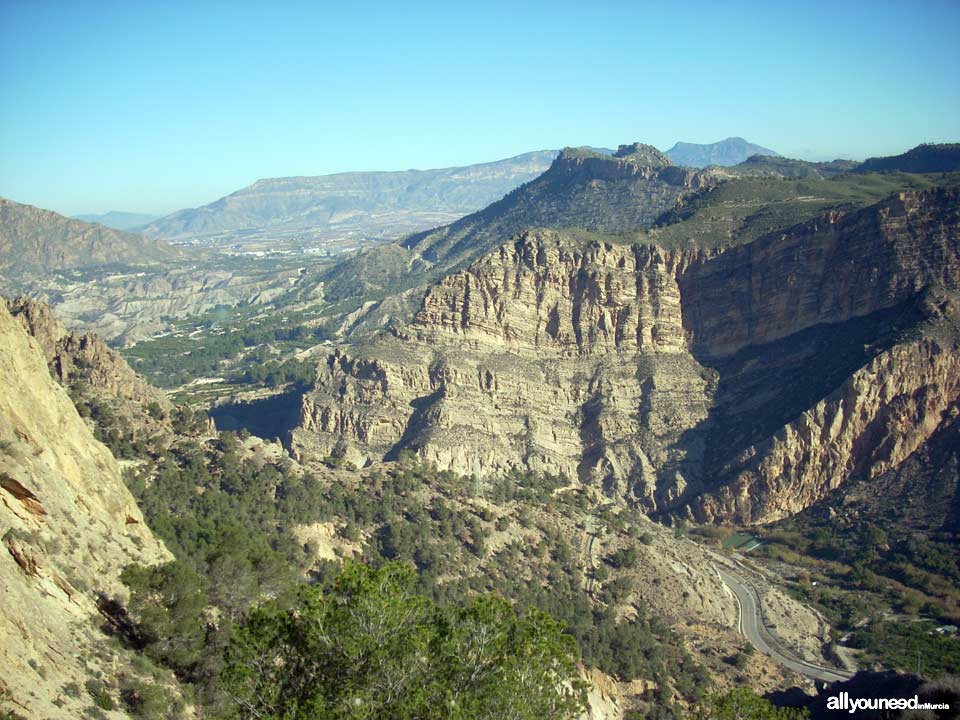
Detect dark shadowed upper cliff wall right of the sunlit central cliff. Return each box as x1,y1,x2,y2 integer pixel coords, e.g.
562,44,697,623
682,188,960,355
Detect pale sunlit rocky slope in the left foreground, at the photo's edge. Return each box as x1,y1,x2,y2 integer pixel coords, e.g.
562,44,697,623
0,303,171,717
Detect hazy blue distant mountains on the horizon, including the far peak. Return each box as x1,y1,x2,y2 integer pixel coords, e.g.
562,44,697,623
142,138,777,245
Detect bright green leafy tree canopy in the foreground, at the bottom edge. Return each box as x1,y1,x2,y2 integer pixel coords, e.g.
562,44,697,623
223,563,585,720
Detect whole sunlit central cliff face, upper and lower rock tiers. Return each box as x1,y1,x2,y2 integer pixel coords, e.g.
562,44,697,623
294,231,711,506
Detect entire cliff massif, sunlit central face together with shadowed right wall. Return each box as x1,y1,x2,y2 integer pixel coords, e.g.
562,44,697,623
293,186,960,521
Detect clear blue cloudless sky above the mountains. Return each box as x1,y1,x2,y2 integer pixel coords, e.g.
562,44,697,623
0,0,960,214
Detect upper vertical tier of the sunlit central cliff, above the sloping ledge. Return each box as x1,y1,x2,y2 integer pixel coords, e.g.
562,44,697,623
411,232,698,355
